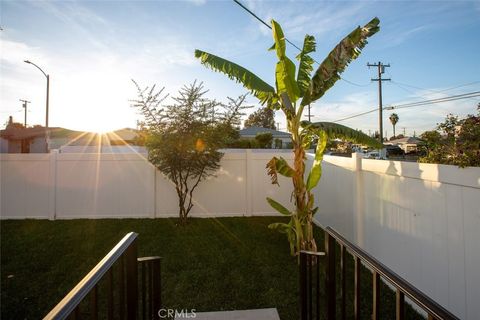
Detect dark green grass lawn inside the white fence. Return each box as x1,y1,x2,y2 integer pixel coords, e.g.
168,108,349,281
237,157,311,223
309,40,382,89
0,217,421,320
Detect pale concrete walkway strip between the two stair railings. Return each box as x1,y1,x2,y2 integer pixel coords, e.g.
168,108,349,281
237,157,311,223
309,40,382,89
175,308,280,320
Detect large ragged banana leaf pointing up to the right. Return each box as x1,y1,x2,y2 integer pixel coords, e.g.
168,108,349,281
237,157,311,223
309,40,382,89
301,18,380,106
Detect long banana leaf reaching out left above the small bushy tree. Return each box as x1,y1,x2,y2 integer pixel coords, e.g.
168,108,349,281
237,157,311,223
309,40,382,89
195,50,278,106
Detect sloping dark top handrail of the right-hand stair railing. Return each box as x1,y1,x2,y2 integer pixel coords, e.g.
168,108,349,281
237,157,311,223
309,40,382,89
325,227,459,320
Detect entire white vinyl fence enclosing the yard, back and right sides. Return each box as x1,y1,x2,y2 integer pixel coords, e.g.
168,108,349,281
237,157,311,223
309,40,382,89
0,150,480,320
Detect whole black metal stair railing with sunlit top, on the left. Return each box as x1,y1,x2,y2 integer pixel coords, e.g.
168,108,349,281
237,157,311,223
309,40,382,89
44,232,161,320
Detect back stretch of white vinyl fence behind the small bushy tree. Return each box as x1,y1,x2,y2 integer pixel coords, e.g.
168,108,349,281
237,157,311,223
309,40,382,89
0,150,292,219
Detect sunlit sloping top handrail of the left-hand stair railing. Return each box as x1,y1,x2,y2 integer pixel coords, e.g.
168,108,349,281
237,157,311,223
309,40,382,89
44,232,138,319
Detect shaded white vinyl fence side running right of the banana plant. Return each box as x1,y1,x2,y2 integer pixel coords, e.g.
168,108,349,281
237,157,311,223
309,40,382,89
315,155,480,320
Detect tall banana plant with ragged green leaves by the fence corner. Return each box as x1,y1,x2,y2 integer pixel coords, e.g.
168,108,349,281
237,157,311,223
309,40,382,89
195,18,380,255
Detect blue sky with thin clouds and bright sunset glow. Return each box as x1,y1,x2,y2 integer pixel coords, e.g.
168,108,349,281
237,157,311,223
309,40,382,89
0,0,480,137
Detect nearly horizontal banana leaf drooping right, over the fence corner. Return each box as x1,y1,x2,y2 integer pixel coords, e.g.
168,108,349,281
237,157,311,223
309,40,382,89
301,121,382,149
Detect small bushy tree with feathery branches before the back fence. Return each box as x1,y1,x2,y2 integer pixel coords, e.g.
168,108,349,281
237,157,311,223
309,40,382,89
132,82,251,225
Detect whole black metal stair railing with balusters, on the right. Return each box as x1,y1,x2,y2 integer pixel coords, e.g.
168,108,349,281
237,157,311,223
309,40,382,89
300,227,458,320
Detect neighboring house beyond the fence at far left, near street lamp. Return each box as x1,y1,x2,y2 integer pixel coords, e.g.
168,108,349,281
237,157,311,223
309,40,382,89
0,117,48,153
